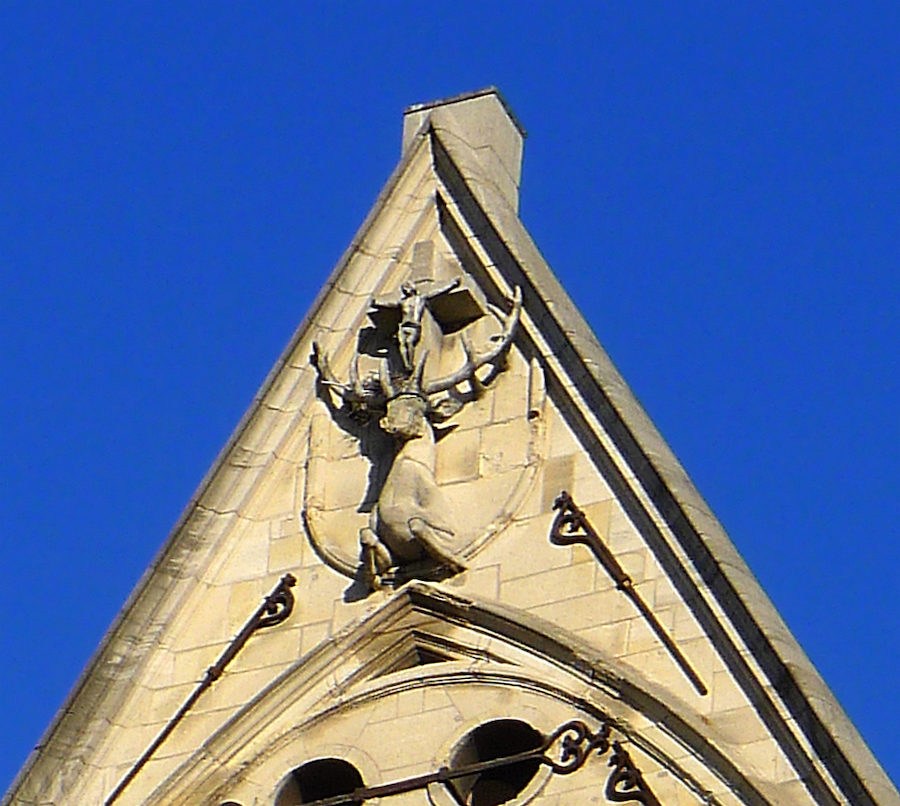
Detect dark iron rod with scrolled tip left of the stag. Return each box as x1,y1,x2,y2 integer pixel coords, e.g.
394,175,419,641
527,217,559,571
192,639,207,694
103,574,297,806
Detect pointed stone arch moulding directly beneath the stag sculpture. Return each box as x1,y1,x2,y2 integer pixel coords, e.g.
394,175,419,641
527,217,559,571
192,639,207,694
145,582,779,806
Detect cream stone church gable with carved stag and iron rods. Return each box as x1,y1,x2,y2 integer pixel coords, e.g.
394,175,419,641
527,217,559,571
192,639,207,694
3,89,900,806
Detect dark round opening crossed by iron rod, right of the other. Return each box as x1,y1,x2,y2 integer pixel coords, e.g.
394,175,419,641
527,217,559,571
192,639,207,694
451,719,544,806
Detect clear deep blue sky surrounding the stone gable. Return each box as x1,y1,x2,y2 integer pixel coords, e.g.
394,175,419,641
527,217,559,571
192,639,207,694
0,0,900,790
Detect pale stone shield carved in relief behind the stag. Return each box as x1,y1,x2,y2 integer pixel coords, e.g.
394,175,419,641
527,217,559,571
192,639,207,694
300,317,546,582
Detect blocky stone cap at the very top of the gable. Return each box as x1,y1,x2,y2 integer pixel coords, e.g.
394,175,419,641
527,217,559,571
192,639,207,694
402,87,525,210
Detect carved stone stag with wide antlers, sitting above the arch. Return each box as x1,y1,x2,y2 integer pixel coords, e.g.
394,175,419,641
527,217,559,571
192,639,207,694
312,288,522,590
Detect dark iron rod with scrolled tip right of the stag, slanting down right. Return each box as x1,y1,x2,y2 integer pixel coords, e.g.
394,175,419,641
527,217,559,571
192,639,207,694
550,490,709,695
